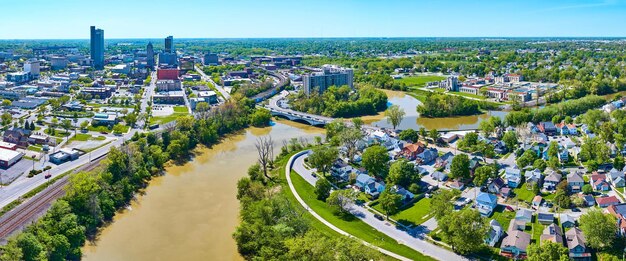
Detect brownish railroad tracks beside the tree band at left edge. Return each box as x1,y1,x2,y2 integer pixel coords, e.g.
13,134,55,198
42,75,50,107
0,154,106,243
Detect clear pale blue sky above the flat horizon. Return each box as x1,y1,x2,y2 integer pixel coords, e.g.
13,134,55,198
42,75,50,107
0,0,626,39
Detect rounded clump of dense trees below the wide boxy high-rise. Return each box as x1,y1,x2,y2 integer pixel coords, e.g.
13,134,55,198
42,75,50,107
289,85,387,118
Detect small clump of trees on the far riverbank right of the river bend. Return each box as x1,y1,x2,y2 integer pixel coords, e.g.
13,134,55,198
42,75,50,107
417,93,497,118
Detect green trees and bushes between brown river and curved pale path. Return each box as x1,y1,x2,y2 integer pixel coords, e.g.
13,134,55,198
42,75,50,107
233,143,384,260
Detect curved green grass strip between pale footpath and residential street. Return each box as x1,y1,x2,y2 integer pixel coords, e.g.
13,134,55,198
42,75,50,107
288,171,433,260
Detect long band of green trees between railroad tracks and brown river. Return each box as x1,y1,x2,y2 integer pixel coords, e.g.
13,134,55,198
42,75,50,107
0,97,269,260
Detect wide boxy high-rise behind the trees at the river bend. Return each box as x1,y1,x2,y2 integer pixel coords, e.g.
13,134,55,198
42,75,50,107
302,66,354,95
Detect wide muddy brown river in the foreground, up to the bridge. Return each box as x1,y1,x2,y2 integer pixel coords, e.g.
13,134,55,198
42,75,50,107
83,121,323,261
